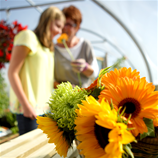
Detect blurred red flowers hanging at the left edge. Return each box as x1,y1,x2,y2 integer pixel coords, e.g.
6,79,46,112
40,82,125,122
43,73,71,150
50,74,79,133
0,20,27,68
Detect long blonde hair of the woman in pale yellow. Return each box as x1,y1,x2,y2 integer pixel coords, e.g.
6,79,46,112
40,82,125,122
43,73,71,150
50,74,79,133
34,6,65,51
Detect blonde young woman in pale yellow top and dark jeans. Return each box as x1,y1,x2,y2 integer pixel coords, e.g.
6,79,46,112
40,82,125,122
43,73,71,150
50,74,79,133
8,7,65,135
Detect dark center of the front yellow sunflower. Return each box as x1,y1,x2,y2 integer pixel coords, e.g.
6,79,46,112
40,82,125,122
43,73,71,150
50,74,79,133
94,124,111,149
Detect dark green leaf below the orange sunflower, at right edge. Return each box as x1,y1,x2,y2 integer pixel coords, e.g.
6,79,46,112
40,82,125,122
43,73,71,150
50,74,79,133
140,118,155,140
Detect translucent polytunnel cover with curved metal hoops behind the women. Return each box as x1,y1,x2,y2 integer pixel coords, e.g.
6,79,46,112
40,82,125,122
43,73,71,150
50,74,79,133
0,0,158,89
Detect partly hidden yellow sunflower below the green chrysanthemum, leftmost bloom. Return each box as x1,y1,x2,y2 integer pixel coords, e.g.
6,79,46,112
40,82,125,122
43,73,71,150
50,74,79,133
37,116,69,157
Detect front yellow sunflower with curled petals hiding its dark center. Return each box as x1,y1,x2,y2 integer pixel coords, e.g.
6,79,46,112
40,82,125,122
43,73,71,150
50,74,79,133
75,96,135,158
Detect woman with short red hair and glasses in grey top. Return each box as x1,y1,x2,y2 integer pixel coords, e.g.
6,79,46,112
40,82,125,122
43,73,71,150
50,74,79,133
54,5,99,88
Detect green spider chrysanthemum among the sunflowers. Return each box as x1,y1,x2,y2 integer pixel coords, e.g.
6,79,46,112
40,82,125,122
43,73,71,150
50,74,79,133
49,82,88,130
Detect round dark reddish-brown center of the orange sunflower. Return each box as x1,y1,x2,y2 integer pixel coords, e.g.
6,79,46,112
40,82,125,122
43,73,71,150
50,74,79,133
118,98,141,118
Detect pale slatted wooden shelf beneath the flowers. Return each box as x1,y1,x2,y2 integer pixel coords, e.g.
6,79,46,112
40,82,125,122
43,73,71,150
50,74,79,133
0,129,79,158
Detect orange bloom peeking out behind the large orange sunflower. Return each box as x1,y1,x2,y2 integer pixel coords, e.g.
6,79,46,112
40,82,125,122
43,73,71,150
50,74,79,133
101,67,140,86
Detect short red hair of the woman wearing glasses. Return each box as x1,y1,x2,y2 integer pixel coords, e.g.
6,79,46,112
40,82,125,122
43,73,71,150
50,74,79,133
62,5,82,26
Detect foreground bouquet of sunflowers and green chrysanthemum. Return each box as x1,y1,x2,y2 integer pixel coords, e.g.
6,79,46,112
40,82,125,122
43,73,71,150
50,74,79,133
37,67,158,158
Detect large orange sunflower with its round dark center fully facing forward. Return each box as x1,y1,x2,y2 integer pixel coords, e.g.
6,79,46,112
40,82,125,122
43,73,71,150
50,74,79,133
99,77,158,136
